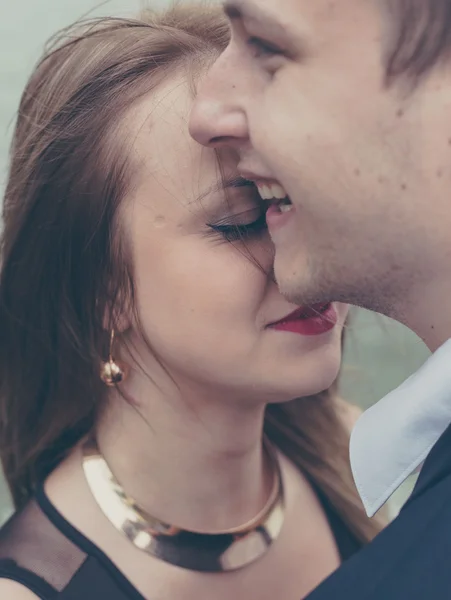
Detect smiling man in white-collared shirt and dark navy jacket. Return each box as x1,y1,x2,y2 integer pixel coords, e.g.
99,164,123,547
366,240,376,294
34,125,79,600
191,0,451,600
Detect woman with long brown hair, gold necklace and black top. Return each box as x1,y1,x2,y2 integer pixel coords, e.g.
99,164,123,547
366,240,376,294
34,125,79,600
0,7,384,600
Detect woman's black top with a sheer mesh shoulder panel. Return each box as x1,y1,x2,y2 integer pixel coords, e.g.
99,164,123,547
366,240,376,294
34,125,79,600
0,487,360,600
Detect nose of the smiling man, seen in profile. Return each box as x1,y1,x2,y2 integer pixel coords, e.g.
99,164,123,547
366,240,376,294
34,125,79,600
189,59,248,148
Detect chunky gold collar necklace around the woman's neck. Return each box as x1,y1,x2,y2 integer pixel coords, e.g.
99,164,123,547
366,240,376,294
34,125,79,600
83,437,285,572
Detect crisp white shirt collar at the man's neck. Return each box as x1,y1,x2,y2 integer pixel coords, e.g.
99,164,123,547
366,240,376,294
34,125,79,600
350,340,451,517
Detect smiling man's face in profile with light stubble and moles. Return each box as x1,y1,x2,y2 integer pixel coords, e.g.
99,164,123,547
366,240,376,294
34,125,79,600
191,0,451,313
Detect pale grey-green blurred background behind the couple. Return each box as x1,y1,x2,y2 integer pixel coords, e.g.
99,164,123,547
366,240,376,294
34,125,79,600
0,0,428,522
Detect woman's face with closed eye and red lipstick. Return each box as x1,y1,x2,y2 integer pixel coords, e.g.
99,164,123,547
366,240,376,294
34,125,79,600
124,80,347,402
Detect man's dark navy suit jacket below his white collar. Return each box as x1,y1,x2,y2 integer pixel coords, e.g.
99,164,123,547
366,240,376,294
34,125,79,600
306,426,451,600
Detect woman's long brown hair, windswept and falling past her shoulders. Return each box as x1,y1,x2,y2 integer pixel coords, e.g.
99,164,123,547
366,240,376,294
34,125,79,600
0,5,377,541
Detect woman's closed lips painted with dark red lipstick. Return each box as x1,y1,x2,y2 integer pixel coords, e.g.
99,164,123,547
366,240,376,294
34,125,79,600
268,304,338,336
